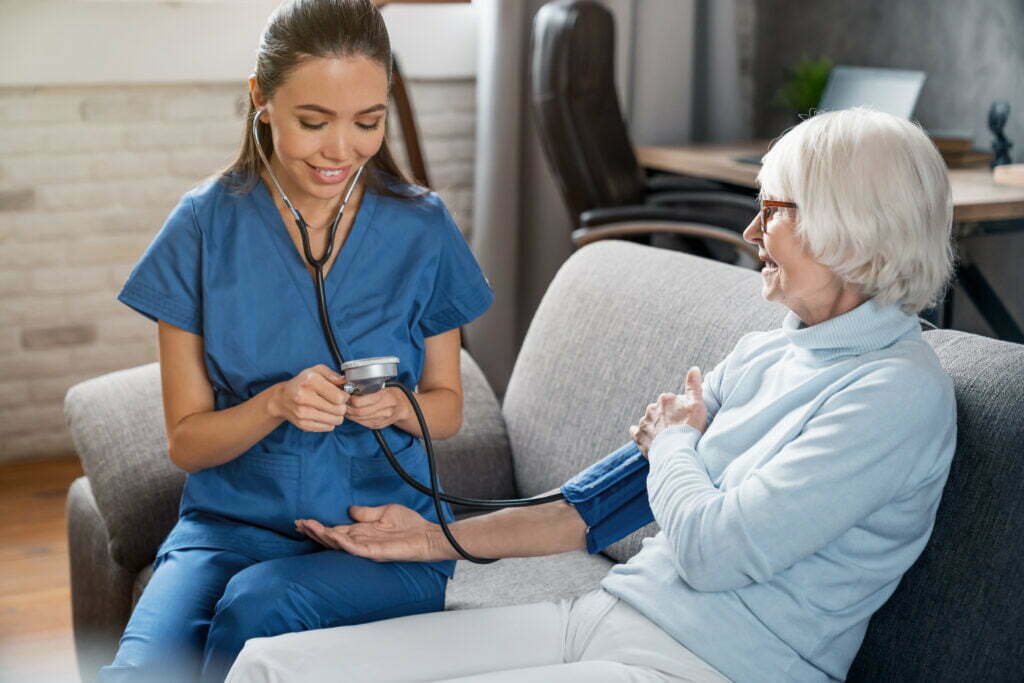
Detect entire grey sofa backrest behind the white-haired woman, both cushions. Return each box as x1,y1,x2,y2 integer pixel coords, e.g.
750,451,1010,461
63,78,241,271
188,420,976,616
504,242,1024,681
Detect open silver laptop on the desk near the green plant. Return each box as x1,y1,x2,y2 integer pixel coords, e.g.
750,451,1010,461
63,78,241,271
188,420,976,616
736,67,925,166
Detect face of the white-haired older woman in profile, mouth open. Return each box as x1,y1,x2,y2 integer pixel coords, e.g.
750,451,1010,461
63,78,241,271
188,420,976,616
743,200,863,326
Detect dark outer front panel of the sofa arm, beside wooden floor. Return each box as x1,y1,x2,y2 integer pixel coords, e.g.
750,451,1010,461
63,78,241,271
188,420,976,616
67,477,135,683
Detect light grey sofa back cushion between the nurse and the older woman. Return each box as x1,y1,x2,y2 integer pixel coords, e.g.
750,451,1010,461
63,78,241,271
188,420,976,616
504,241,785,562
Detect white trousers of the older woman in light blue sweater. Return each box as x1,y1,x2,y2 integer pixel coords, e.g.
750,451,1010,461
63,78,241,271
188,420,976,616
227,589,728,683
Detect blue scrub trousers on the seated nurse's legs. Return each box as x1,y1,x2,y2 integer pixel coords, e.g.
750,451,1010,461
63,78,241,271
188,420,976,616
99,548,447,683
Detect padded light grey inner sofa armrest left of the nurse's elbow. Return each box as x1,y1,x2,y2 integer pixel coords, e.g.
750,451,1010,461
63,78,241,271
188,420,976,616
65,362,184,572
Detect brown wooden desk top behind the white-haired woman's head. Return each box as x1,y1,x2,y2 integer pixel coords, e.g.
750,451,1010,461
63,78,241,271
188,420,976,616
636,141,1024,223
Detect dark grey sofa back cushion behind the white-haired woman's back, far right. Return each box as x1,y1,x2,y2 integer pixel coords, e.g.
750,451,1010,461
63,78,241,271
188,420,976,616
849,330,1024,681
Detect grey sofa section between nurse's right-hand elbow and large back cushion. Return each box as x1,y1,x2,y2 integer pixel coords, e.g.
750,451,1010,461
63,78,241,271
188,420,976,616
436,350,516,514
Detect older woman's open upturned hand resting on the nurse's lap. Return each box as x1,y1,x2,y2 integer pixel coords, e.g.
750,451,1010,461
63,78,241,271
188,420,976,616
295,504,455,562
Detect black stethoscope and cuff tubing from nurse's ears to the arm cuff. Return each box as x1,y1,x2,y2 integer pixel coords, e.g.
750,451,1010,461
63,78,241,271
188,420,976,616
252,110,565,564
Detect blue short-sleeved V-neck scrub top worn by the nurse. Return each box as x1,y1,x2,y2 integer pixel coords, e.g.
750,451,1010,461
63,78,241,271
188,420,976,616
118,172,494,577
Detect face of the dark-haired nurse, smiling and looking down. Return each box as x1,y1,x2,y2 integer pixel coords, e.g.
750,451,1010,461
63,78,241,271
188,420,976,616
249,56,388,209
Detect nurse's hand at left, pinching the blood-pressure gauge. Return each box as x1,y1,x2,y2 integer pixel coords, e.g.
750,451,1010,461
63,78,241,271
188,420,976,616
268,366,349,432
